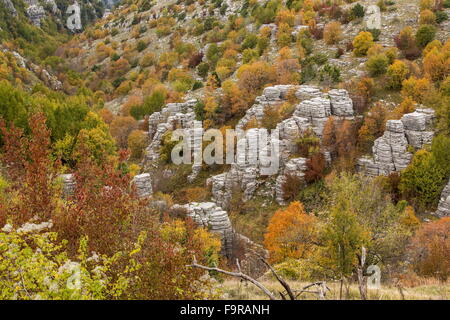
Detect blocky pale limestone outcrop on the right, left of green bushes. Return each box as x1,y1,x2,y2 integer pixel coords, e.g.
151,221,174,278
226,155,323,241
358,109,434,176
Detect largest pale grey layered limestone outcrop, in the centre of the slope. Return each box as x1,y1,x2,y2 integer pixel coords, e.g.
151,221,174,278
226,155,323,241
207,85,354,208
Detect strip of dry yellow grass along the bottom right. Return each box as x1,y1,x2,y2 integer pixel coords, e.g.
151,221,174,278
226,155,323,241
222,279,450,300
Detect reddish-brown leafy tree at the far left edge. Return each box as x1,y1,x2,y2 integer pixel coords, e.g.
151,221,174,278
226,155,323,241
0,113,58,224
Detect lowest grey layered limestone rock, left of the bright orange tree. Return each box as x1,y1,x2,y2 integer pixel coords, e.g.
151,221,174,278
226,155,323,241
172,202,234,257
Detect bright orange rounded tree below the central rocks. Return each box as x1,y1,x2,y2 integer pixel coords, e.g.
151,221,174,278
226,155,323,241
264,201,317,262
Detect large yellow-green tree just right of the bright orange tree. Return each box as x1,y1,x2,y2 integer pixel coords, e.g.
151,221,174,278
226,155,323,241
317,172,411,286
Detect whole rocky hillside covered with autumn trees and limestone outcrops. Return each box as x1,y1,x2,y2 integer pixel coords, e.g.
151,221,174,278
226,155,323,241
0,0,450,299
